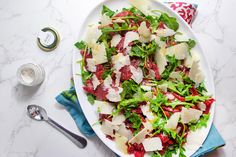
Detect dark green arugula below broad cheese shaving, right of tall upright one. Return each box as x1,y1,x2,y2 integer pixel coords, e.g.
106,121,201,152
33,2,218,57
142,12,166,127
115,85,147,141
161,56,180,79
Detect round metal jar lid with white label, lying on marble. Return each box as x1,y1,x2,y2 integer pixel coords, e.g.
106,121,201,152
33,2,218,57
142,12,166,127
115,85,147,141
37,27,60,52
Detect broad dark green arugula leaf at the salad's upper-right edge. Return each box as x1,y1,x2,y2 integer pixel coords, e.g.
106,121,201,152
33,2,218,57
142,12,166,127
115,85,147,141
159,13,179,31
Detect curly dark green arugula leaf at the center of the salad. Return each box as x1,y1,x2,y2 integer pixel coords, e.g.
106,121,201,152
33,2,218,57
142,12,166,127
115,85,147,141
121,80,139,100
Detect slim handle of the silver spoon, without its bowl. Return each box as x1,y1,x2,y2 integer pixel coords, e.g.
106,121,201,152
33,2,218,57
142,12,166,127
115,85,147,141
46,117,87,148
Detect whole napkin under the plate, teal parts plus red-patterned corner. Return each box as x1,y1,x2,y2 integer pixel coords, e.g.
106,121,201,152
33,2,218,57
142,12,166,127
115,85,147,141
56,2,225,157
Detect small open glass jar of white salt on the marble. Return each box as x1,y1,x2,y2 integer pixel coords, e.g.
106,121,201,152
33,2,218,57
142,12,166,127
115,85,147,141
17,63,45,86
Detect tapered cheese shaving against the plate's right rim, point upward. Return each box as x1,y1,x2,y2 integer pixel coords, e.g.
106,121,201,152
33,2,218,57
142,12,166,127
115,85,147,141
189,61,204,84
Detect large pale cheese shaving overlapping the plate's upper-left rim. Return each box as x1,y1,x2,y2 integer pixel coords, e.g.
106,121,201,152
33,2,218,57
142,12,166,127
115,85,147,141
84,24,102,47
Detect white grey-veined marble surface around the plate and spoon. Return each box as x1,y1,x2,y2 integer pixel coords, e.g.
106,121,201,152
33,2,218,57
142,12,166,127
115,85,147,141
0,0,236,157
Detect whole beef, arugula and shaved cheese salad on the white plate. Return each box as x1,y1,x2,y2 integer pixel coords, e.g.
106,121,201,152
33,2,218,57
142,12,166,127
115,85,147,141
75,0,214,157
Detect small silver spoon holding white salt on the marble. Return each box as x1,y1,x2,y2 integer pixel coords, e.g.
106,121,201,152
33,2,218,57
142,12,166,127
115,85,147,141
27,105,87,148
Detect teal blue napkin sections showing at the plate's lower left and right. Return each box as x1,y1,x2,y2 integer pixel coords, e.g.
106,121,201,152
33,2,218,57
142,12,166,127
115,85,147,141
56,87,225,157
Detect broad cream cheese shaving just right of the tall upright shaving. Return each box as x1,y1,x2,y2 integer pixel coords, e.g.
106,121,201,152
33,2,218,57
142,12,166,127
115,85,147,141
166,43,188,60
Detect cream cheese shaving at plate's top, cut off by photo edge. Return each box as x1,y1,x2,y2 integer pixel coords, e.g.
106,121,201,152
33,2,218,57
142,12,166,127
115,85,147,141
129,0,150,15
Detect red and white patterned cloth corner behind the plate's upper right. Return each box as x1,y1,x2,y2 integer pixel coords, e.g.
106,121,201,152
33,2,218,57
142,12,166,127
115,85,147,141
167,2,197,25
